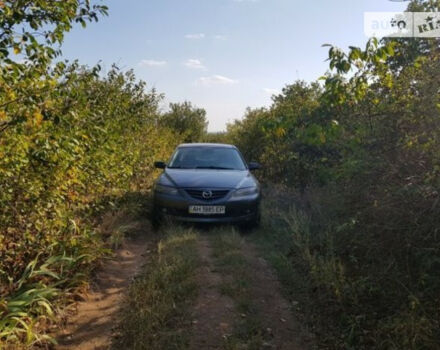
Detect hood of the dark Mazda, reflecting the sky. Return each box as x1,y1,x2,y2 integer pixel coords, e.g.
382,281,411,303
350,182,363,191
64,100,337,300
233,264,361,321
159,169,256,188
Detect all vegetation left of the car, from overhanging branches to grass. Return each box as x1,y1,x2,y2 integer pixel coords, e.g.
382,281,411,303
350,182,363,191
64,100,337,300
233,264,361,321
0,0,206,349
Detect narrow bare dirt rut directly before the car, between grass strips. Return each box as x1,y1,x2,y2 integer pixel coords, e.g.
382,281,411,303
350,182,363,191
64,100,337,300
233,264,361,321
190,236,236,350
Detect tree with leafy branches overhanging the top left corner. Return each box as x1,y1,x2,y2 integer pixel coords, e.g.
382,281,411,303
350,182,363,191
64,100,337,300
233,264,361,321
0,0,107,137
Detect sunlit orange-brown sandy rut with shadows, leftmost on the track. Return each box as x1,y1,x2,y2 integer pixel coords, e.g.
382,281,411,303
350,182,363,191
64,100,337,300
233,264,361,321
56,223,148,350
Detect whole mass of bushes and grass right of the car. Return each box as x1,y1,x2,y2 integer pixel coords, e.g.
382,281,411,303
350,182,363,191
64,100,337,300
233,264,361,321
221,2,440,349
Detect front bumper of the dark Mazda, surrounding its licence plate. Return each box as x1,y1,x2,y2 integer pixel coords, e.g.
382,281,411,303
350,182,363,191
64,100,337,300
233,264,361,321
154,192,261,223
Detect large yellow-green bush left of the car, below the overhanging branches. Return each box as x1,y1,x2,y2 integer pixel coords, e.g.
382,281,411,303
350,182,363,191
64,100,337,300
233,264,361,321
0,64,179,345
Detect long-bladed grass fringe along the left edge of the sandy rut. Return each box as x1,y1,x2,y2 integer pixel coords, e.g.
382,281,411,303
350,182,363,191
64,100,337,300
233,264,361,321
0,193,149,350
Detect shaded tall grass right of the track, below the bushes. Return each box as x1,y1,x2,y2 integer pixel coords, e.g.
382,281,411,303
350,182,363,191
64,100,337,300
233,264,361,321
249,189,440,349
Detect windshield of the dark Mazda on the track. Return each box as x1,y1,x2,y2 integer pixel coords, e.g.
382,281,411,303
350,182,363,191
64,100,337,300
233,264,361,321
168,147,246,170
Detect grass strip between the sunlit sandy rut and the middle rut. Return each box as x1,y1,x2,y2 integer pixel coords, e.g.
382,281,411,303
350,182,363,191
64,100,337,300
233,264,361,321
114,226,199,350
